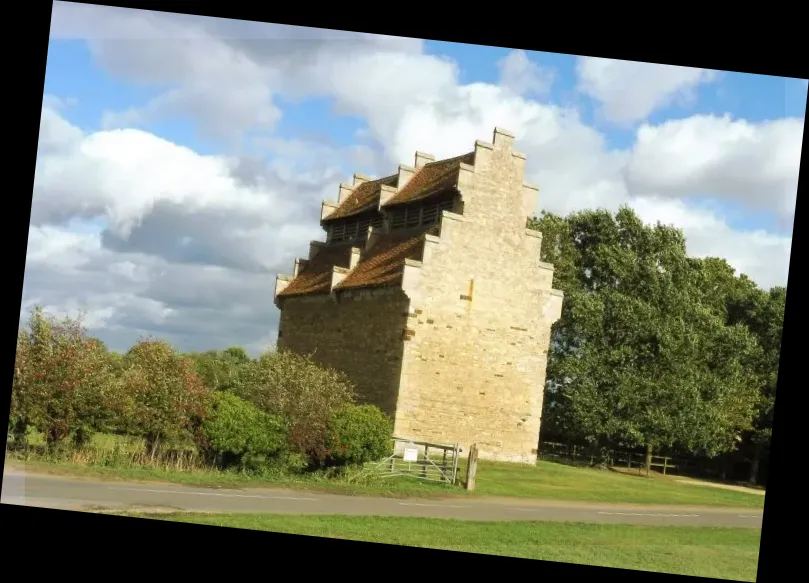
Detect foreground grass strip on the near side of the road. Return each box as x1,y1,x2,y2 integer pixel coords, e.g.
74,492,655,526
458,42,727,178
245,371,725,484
131,513,761,581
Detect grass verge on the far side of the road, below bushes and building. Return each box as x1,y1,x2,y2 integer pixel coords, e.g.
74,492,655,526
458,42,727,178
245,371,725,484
6,435,764,508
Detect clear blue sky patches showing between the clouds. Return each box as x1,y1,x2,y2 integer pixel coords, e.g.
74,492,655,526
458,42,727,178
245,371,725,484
45,40,806,235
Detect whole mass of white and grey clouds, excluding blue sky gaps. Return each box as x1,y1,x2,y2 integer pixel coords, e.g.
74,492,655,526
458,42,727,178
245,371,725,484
31,2,803,356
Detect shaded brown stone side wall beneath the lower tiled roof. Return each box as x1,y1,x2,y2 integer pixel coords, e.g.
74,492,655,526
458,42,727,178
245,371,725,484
277,288,408,417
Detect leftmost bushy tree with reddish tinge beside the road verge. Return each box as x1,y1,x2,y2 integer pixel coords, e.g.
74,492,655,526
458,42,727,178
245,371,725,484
10,306,113,447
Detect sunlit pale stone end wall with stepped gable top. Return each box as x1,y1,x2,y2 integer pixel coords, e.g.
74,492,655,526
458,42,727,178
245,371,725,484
395,129,561,463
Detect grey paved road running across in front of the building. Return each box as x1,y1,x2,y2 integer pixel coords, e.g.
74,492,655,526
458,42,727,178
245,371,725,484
0,469,762,528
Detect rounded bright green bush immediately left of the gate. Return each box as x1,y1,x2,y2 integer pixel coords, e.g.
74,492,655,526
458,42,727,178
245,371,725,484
326,405,393,465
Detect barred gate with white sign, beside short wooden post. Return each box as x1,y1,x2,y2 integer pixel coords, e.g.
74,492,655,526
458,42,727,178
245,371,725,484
371,437,461,484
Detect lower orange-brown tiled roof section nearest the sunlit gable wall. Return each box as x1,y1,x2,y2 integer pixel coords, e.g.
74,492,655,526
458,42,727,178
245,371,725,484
335,228,437,290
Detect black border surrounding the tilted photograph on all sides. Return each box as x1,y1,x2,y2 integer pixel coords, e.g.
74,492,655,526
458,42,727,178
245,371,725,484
0,0,808,581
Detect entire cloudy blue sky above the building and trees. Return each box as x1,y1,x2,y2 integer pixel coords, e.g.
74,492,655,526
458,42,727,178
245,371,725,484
33,2,806,351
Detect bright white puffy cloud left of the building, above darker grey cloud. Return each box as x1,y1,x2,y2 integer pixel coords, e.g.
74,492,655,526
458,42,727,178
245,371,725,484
31,109,321,269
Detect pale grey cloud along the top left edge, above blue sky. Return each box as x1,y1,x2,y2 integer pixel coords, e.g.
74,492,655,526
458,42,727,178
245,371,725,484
51,2,421,141
